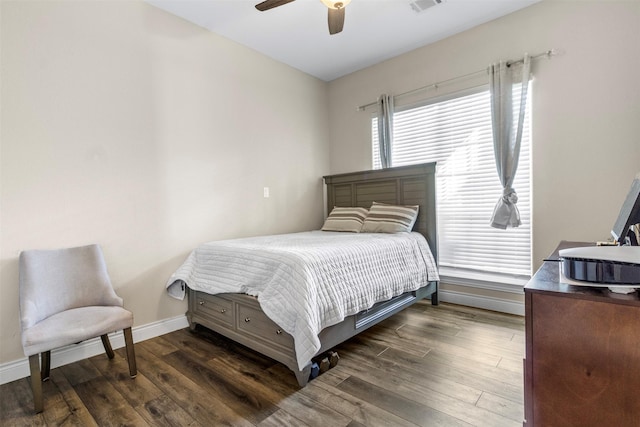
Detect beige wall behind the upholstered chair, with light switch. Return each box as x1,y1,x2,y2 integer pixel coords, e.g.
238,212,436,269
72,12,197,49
0,0,329,363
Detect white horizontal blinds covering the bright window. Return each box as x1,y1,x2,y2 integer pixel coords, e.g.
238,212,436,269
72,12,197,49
371,87,531,275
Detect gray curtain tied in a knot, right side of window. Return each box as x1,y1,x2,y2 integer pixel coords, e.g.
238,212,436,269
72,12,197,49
489,54,531,230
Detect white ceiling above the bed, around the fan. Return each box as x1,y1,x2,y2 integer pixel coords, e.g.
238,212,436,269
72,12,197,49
146,0,540,81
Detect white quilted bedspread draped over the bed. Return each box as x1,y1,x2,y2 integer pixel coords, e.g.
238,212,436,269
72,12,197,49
166,231,439,370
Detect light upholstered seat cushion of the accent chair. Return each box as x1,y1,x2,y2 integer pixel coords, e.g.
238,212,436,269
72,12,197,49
22,306,133,356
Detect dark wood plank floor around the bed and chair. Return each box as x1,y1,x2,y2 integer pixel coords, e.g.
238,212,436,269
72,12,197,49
0,301,524,427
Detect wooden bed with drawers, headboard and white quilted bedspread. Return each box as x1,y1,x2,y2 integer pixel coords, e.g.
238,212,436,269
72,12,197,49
167,163,438,387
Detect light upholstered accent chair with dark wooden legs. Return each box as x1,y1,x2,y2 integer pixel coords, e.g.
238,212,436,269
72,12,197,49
19,245,137,413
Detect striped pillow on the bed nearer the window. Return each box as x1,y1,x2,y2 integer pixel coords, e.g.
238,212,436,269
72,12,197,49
362,202,419,233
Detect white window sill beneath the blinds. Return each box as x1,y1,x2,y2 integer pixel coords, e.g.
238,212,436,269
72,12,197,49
440,267,531,294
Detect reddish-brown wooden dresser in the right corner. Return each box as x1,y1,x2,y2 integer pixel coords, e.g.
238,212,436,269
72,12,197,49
523,241,640,427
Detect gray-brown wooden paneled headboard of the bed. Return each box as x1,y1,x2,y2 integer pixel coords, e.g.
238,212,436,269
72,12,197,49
323,163,438,261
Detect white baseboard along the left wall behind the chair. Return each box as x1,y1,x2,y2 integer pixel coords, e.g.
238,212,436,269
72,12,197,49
0,316,189,384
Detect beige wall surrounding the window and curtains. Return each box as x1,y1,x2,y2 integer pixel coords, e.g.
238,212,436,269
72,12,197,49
329,0,640,294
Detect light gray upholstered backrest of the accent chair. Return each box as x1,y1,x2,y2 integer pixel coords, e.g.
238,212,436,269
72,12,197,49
19,245,122,330
